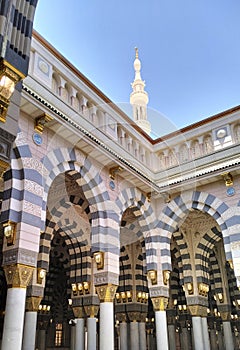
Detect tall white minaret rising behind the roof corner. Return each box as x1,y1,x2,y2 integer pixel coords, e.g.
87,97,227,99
130,48,151,134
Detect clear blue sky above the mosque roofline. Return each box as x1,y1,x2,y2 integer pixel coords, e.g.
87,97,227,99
34,0,240,135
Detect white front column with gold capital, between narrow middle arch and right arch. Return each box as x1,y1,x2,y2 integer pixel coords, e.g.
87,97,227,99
152,296,169,350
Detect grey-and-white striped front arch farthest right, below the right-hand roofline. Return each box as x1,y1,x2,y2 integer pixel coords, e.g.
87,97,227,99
157,191,237,269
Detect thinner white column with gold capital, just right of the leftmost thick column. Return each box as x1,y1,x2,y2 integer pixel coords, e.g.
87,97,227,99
22,296,42,350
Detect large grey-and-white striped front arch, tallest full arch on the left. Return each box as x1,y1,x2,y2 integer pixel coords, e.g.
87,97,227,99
42,148,119,255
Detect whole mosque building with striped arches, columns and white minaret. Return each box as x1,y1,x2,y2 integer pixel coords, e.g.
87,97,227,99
0,0,240,350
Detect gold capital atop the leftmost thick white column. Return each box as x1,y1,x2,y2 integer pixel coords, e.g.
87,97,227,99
3,264,34,288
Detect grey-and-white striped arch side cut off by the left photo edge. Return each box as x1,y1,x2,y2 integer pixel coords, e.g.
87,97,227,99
1,136,43,230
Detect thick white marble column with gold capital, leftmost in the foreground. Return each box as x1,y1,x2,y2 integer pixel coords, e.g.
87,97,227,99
2,264,34,350
